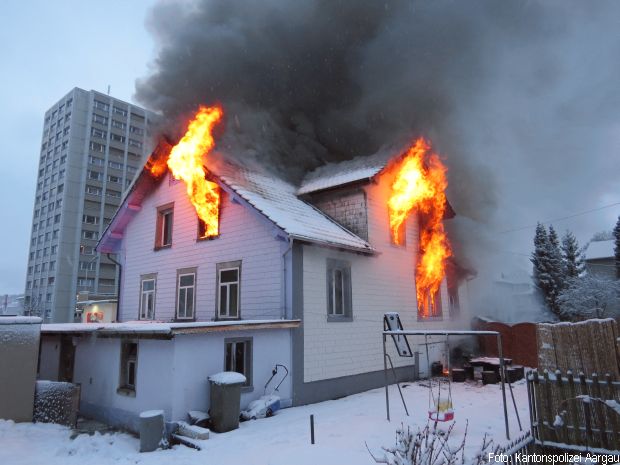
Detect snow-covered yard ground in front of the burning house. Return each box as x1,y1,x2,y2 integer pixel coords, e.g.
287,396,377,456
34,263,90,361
0,380,529,465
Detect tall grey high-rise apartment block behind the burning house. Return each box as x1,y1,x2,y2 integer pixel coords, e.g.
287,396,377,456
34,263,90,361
24,88,155,323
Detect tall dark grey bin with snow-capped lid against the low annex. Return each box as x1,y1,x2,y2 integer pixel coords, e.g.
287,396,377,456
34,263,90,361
209,371,246,433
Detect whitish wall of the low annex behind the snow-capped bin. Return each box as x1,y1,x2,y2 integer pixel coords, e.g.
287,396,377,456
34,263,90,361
69,329,292,430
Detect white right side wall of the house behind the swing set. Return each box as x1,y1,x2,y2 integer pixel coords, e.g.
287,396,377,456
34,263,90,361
303,169,458,382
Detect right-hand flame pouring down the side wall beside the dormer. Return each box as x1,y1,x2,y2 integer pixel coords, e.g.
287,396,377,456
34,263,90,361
388,138,452,317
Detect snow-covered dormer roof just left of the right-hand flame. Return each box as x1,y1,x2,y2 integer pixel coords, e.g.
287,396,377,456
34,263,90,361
297,150,398,195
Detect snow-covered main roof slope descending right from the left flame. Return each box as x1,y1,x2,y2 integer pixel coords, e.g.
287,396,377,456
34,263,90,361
210,156,373,252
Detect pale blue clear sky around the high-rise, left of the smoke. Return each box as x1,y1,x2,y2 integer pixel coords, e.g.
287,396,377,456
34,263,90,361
0,0,154,295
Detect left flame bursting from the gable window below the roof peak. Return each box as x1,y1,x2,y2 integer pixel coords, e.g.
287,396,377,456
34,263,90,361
163,106,224,237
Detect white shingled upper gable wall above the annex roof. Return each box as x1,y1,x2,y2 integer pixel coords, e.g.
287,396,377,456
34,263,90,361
119,176,288,321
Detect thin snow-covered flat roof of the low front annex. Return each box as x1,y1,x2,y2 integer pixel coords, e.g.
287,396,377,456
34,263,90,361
41,320,299,337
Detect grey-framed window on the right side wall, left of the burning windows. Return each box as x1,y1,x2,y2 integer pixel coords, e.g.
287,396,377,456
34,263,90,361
327,258,353,321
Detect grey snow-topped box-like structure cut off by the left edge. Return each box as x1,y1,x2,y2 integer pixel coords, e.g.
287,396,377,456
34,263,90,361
0,316,41,422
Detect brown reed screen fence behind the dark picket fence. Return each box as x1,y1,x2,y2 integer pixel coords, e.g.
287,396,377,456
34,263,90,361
537,318,620,381
